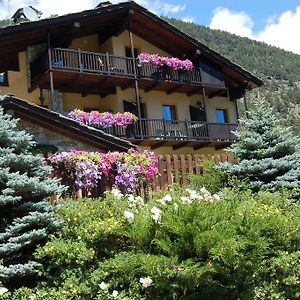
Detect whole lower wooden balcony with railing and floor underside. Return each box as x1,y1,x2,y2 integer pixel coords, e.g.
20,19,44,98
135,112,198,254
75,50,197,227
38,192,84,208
99,119,237,149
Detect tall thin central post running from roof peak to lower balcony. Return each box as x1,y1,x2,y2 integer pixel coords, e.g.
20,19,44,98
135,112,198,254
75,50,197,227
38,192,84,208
128,9,143,139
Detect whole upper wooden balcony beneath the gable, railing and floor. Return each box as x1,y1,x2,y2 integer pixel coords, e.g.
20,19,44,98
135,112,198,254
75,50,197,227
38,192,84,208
29,48,225,96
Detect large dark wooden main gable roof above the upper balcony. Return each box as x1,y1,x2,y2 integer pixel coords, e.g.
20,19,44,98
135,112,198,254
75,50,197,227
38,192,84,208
0,1,263,87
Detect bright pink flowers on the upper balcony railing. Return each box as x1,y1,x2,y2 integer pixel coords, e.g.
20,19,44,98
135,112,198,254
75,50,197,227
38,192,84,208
138,53,193,71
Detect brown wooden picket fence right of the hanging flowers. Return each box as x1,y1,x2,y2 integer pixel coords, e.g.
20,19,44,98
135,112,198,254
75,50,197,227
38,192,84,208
153,154,236,190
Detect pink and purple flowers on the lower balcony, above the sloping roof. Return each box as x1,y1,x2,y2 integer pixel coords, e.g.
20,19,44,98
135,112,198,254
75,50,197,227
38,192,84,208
68,109,137,128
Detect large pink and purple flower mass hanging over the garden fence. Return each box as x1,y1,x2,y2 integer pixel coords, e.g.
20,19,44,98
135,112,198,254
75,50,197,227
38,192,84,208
50,149,158,193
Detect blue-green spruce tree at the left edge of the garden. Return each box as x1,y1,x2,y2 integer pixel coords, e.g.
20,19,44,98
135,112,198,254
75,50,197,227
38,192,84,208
0,103,64,287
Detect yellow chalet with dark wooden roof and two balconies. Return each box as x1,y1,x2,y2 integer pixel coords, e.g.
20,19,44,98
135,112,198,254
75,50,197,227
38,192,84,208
0,2,262,154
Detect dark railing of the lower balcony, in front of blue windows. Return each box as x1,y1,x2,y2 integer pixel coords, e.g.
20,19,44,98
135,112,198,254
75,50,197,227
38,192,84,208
99,119,237,141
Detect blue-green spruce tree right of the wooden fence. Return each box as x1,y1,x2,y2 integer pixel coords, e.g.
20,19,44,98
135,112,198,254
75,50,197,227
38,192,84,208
222,101,300,199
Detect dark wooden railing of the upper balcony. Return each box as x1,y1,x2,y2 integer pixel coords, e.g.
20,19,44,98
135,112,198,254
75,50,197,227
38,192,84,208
31,48,219,85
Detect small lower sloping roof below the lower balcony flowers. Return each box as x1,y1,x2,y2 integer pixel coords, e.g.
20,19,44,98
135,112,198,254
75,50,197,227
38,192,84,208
0,96,136,151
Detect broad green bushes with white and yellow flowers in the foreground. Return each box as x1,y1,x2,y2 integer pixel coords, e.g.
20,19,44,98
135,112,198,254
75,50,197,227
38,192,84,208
4,189,300,300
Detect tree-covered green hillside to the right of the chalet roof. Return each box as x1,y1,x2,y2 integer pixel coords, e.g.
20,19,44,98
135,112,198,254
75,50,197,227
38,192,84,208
167,19,300,133
